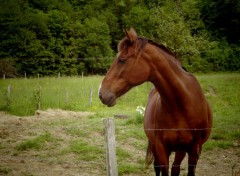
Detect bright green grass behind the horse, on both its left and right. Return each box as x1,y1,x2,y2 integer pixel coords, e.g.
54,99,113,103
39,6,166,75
0,73,240,149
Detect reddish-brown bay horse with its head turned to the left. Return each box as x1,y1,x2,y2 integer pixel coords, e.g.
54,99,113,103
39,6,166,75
99,28,212,176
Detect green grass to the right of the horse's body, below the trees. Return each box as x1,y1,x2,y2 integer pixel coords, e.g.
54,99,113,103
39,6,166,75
197,73,240,149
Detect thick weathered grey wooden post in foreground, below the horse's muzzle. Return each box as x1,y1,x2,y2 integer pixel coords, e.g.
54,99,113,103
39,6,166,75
104,118,118,176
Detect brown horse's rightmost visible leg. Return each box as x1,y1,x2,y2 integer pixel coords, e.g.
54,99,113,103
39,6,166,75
188,145,202,176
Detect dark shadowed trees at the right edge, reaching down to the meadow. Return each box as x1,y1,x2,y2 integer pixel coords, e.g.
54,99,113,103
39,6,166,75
198,0,240,71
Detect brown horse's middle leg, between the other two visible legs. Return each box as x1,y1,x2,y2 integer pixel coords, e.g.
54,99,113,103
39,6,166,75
171,151,186,176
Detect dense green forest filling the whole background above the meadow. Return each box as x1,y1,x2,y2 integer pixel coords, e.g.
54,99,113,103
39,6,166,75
0,0,240,77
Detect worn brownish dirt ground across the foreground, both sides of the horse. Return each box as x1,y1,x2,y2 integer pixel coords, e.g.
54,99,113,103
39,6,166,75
0,109,240,176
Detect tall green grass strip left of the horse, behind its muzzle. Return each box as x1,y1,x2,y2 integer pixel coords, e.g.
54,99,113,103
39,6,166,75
0,76,152,116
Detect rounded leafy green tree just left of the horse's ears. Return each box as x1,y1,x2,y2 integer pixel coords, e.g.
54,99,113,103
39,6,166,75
79,17,113,73
